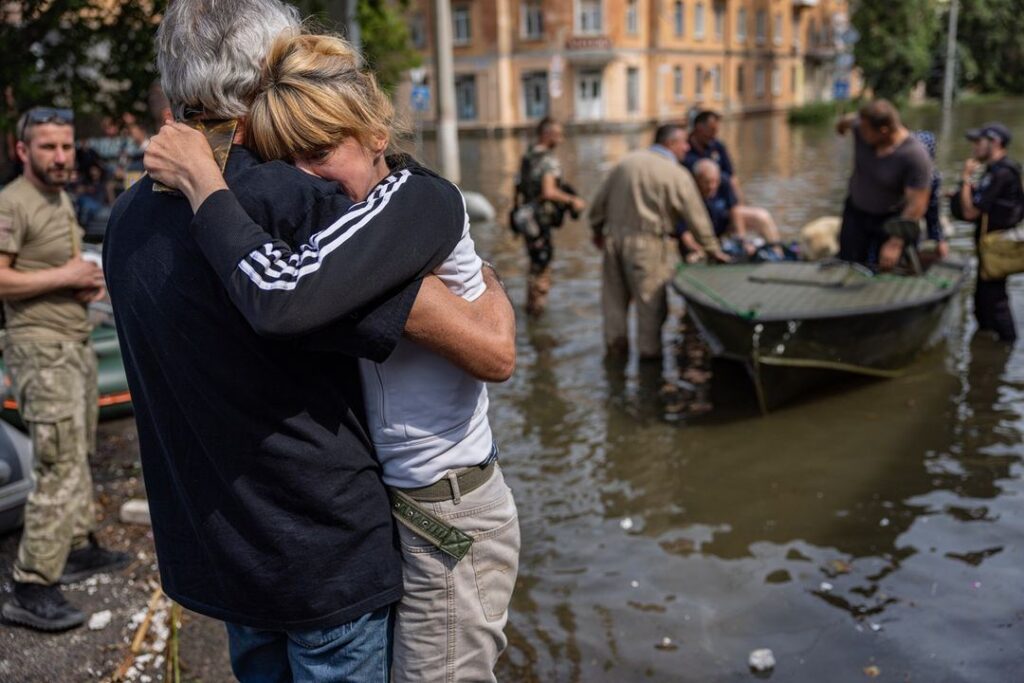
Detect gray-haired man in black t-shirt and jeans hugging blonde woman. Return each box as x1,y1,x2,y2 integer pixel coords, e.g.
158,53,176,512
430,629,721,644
104,0,513,682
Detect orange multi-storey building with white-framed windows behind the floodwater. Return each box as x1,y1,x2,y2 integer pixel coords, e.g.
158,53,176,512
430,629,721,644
397,0,848,130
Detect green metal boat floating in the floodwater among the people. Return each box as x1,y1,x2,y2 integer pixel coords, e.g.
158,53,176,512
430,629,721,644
673,261,966,413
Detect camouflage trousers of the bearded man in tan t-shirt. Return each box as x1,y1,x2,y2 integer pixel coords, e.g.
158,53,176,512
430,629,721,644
3,342,98,585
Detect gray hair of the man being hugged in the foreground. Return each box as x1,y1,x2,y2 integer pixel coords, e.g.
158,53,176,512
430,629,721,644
157,0,301,119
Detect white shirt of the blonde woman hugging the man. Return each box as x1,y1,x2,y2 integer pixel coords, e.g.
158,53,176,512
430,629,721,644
359,200,493,488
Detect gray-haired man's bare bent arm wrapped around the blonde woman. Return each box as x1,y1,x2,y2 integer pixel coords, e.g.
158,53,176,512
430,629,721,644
406,266,515,382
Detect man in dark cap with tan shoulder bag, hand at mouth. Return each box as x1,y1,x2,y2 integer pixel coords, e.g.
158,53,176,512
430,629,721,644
950,123,1024,342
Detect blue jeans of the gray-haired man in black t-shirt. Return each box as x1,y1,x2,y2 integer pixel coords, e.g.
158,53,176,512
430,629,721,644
226,606,394,683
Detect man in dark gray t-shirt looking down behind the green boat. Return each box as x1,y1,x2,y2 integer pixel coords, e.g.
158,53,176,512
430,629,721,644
836,99,932,269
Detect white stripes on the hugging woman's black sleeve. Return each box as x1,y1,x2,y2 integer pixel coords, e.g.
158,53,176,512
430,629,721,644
239,171,412,290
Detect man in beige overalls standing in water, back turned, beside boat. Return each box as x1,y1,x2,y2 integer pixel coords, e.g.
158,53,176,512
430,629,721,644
589,124,727,360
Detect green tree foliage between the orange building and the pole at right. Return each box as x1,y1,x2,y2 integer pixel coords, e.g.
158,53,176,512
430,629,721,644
853,0,941,98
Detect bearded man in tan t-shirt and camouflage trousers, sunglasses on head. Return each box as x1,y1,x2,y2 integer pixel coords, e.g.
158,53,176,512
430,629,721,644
0,108,130,631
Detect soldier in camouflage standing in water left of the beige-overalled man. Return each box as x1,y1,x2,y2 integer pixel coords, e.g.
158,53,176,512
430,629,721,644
520,117,586,315
